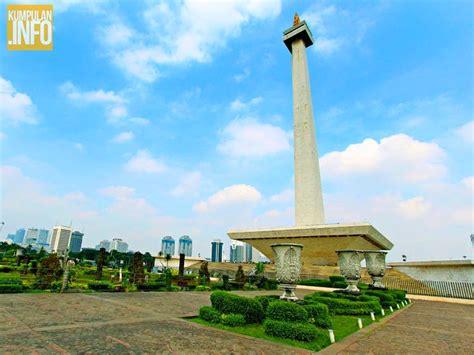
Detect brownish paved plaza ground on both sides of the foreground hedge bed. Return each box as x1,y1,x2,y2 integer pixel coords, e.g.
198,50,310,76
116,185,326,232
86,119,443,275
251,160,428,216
0,290,474,354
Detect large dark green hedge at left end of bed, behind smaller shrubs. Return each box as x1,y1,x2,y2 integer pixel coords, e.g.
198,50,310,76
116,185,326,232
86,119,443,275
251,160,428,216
211,291,264,323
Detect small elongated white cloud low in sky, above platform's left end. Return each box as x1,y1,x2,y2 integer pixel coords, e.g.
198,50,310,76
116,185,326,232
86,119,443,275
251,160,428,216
193,184,262,213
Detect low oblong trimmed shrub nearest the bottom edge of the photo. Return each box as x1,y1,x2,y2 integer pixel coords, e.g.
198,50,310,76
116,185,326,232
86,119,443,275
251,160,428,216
263,319,318,341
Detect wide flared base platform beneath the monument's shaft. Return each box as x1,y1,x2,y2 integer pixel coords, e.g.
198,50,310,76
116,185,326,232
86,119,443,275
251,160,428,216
227,223,393,266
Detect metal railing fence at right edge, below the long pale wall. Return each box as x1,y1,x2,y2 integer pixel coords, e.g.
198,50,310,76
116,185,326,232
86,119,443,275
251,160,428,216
383,277,474,300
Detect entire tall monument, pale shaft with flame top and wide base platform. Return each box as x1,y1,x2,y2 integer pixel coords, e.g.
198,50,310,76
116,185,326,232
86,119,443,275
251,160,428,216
227,15,393,266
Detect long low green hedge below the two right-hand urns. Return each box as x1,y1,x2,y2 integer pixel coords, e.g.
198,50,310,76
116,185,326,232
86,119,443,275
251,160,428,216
304,292,381,315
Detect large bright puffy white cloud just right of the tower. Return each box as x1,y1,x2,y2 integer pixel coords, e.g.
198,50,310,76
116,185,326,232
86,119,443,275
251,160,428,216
320,134,447,183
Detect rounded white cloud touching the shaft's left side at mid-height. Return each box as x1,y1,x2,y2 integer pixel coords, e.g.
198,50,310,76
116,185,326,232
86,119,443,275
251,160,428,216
217,118,291,158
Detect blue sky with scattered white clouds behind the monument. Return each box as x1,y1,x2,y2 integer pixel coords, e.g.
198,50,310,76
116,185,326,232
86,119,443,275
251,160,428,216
0,0,474,260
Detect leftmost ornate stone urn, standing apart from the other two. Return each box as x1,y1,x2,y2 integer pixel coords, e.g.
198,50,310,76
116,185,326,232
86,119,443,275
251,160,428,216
271,243,303,301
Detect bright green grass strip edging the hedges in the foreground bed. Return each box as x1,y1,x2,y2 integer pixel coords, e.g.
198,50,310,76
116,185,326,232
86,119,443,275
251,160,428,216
189,310,391,351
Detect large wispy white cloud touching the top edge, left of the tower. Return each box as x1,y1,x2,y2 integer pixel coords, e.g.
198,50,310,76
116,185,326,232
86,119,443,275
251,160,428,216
99,0,281,82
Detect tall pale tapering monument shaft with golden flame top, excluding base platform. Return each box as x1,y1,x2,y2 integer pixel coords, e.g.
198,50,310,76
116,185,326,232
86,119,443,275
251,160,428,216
283,14,325,226
